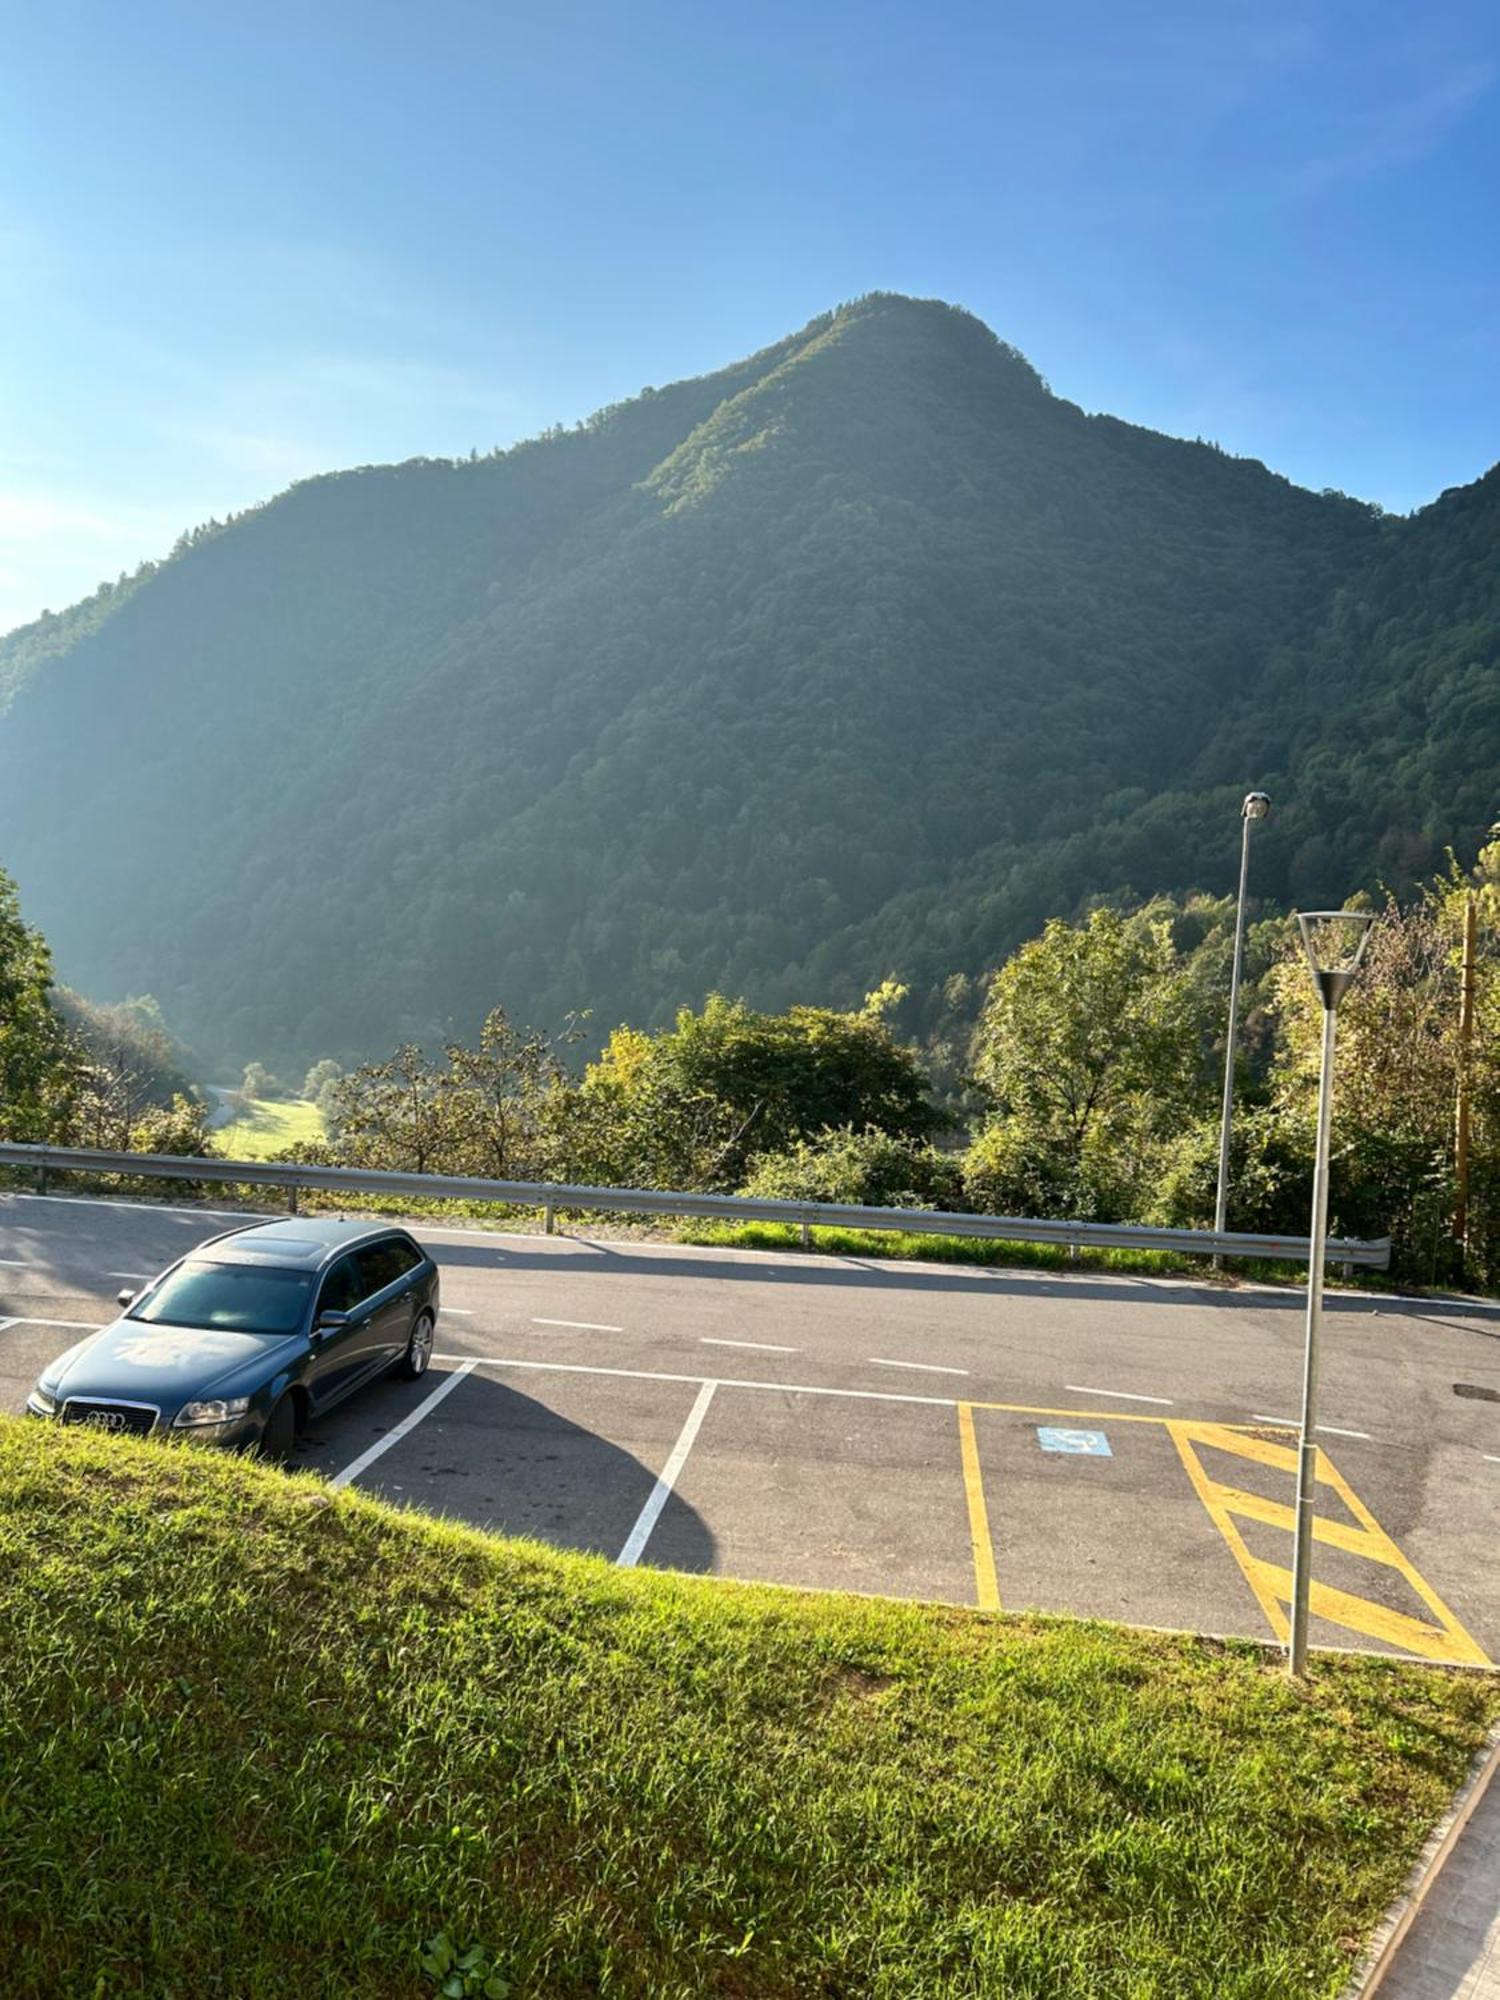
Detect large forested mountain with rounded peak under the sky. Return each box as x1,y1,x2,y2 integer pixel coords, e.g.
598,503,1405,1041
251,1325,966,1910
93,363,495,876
0,296,1500,1068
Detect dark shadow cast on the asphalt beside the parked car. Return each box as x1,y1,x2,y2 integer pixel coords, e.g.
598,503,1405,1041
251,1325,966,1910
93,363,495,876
292,1368,716,1572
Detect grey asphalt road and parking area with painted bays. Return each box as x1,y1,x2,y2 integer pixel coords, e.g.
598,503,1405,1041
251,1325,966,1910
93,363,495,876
0,1194,1500,1662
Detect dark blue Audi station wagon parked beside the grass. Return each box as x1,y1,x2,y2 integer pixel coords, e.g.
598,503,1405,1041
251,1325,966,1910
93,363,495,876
26,1218,438,1458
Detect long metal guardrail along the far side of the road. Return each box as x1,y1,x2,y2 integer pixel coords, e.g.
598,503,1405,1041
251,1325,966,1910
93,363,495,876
0,1144,1390,1270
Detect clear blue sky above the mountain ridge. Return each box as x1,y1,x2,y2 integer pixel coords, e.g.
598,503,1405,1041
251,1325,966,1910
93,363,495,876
0,0,1500,630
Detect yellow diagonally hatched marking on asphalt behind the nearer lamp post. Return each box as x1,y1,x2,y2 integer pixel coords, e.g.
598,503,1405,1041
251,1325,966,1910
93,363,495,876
1166,1420,1490,1666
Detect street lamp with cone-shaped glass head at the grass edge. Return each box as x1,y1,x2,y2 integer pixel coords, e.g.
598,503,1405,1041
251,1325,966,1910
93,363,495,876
1286,910,1374,1674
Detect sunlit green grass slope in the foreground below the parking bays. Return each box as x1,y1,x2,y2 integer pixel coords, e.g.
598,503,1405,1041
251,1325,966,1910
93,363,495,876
0,1420,1500,2000
